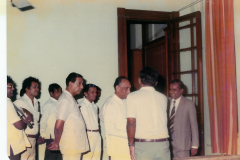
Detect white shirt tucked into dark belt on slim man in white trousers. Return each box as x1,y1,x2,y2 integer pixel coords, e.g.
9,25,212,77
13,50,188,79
79,98,99,130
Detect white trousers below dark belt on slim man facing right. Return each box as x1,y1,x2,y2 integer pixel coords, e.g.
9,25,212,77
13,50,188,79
82,132,101,160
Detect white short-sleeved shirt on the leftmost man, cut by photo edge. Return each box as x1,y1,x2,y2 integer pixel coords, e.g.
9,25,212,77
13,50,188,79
7,98,31,156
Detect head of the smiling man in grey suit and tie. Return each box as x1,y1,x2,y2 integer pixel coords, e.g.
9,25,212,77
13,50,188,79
169,79,184,99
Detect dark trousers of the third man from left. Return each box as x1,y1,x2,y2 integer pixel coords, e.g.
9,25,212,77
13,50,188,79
44,139,62,160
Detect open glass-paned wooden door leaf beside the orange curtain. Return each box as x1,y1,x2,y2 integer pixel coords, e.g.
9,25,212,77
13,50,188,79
165,11,204,155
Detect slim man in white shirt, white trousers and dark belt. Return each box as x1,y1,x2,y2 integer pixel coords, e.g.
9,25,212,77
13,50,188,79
79,84,101,160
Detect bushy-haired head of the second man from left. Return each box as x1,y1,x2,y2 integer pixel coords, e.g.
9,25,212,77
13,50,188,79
20,77,40,97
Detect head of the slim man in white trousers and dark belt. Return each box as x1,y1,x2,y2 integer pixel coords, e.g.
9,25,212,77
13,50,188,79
83,84,97,103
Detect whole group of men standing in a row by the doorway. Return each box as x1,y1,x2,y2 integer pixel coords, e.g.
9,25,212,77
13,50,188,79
7,67,199,160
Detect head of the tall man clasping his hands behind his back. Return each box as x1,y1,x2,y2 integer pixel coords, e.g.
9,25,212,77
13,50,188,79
66,72,83,96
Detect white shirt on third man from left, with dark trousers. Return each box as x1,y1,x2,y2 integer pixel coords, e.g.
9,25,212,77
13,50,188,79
40,97,57,139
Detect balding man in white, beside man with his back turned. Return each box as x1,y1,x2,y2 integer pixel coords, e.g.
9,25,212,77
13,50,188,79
99,76,131,160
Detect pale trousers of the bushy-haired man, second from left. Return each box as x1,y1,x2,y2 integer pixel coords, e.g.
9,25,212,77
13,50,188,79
21,137,36,160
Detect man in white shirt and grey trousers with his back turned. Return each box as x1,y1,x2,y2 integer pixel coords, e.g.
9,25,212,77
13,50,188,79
126,67,170,160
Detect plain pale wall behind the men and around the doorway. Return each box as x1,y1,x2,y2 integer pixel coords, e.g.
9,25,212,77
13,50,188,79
7,0,240,159
